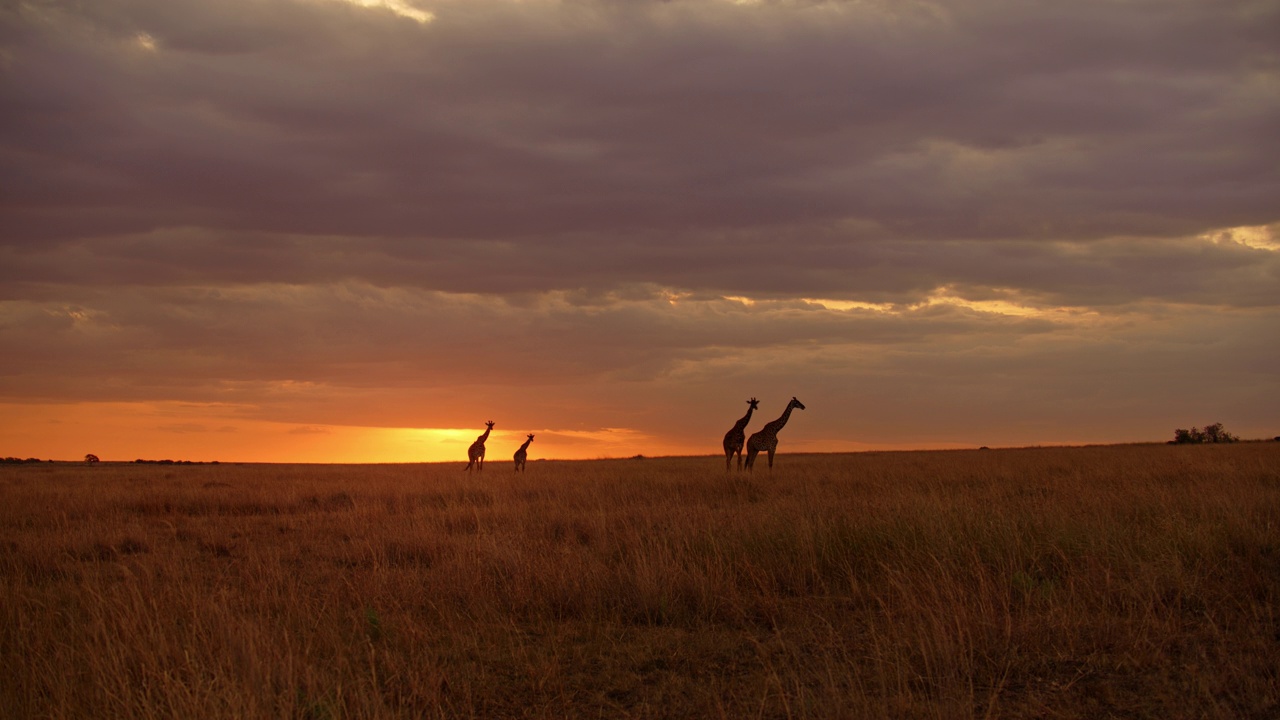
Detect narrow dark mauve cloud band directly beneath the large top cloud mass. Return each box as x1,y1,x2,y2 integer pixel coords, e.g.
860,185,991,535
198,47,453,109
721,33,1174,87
0,225,1280,307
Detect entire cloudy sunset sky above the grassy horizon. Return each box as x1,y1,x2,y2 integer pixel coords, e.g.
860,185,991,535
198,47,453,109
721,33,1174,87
0,0,1280,462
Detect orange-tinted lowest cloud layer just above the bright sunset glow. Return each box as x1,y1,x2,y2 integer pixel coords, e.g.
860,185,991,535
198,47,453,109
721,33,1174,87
0,275,1276,429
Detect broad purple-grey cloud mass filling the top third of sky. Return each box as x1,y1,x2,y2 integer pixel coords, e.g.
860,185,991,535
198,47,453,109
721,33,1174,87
6,1,1280,243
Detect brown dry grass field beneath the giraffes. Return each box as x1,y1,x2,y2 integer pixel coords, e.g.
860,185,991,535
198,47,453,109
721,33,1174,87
0,442,1280,719
